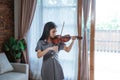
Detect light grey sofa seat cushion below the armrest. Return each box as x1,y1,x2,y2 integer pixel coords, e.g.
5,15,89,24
0,72,26,80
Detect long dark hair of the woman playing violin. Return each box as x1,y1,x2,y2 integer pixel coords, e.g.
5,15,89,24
40,22,57,40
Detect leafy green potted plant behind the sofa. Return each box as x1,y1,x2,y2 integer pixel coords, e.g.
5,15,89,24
4,37,26,62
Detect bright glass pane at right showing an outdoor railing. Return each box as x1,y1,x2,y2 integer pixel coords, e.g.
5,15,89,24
95,0,120,80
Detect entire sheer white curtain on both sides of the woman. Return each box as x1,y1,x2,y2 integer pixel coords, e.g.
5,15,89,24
27,0,78,80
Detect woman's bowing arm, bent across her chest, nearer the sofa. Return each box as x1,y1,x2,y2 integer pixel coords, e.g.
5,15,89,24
37,46,58,58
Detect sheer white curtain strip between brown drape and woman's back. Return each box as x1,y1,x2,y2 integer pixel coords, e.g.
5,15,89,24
26,1,43,80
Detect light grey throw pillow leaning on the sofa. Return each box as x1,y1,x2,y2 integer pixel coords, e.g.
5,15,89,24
0,53,13,74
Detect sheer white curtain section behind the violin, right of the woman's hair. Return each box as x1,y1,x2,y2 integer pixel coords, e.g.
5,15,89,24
43,0,78,80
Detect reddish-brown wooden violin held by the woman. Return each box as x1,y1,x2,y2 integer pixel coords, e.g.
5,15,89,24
52,35,82,44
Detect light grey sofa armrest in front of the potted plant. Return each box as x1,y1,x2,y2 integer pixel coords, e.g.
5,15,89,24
11,63,29,74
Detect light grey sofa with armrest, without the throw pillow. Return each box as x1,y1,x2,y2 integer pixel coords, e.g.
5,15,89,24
0,52,29,80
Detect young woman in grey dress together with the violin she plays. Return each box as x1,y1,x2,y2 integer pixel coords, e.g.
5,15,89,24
35,22,82,80
